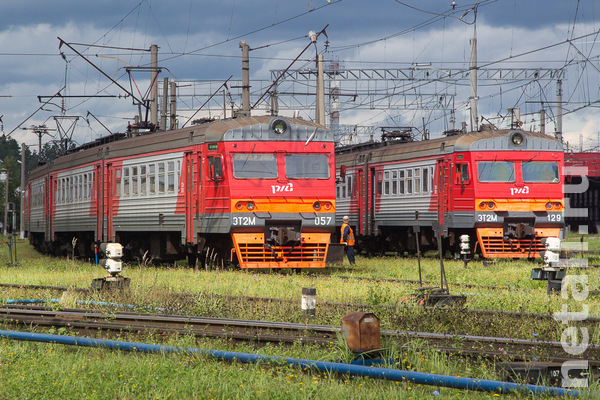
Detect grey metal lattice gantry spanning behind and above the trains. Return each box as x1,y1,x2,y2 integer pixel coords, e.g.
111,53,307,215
159,61,565,143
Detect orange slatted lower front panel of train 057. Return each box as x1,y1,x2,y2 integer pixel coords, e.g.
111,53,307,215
231,233,331,268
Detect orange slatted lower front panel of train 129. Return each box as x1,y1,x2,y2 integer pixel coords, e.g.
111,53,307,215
477,228,560,258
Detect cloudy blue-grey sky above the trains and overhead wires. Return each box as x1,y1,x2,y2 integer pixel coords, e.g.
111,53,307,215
0,0,600,148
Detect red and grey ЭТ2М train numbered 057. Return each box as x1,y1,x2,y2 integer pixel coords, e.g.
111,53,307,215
25,116,336,268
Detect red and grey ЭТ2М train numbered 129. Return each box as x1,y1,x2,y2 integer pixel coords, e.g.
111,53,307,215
336,128,565,258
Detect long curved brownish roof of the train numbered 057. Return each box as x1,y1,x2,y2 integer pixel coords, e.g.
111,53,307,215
29,115,333,178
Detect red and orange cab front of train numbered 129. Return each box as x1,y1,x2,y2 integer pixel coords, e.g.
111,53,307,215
474,130,565,258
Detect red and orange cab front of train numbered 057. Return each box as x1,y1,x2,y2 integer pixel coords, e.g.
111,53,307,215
225,117,335,268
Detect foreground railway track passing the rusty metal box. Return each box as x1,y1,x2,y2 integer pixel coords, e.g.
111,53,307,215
0,306,600,368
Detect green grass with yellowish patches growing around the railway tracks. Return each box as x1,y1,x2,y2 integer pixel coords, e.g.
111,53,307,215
0,239,600,399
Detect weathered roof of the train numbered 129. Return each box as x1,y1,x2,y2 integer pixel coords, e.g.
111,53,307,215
336,129,564,163
